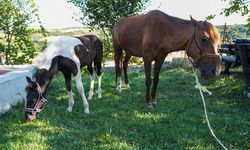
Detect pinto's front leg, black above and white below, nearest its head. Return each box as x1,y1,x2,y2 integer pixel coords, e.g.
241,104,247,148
63,73,74,112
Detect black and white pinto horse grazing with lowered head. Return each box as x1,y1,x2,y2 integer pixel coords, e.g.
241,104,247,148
25,35,103,121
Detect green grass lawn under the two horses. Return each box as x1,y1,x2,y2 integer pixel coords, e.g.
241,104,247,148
0,67,250,150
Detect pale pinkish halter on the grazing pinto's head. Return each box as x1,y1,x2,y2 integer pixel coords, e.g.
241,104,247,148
25,81,47,114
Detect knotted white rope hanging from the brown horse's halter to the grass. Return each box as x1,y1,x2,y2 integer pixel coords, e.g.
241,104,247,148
193,67,227,150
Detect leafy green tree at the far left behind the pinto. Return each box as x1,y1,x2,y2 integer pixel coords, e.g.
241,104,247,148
0,0,45,64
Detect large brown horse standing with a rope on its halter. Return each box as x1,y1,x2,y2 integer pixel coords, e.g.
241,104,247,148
112,10,221,109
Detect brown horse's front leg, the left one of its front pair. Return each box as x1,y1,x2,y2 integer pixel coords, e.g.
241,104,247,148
143,58,153,110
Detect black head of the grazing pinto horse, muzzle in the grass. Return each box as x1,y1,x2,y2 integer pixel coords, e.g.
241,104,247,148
25,69,51,121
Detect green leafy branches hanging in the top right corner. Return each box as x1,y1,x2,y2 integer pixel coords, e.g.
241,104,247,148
222,0,250,31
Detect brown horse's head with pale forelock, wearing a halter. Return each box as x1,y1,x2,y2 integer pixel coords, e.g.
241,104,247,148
186,17,221,79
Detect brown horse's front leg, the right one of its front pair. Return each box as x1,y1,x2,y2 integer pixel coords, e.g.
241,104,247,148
151,57,165,104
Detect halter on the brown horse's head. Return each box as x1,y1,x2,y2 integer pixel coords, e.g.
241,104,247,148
185,23,220,67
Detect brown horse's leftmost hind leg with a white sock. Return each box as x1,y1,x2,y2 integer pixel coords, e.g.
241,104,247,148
114,48,122,93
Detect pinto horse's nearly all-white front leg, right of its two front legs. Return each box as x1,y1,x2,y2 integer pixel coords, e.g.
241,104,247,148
76,67,89,113
